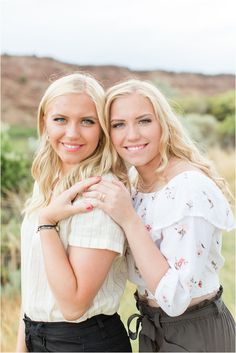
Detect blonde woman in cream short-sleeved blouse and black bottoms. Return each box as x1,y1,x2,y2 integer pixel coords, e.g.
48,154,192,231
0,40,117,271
17,73,131,352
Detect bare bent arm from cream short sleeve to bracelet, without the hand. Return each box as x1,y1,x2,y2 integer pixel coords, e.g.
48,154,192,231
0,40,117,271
40,224,117,321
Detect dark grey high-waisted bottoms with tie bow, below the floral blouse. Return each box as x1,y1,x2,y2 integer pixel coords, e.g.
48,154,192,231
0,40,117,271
128,287,235,352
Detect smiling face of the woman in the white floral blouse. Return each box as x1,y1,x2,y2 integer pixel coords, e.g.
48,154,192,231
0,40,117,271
110,93,161,167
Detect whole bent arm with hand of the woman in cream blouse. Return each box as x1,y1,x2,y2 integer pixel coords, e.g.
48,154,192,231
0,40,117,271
39,178,117,321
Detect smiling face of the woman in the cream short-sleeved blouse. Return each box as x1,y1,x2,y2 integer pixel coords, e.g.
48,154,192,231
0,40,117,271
44,93,101,173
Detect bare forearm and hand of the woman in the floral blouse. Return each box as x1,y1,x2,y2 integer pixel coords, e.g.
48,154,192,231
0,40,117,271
83,181,169,293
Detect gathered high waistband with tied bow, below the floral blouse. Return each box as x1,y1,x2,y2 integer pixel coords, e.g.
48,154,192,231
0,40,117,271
127,286,223,340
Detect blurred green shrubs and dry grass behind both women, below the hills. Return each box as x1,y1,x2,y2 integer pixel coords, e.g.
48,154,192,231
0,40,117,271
1,79,235,351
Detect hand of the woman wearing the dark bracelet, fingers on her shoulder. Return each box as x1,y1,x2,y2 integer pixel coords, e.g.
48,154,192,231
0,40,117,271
39,177,101,224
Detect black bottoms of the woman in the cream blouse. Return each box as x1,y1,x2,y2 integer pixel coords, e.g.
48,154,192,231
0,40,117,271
24,314,132,352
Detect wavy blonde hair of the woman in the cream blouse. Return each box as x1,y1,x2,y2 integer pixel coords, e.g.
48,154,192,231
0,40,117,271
25,73,125,212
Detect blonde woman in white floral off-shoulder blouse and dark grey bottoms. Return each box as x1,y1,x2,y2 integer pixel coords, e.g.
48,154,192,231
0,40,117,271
84,80,235,352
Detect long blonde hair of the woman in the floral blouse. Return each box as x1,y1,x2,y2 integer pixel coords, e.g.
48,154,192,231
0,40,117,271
105,79,231,195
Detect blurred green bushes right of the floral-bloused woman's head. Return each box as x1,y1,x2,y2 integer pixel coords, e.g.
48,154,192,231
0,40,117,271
172,91,235,148
